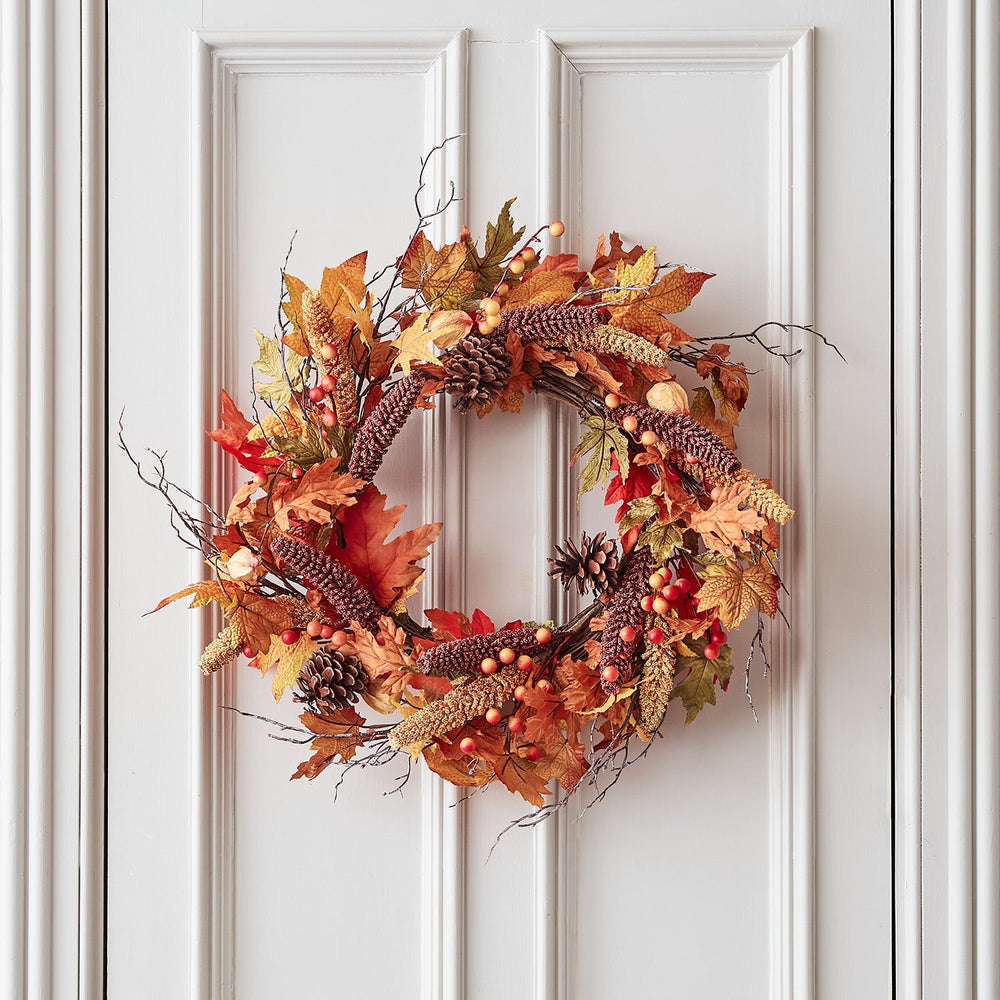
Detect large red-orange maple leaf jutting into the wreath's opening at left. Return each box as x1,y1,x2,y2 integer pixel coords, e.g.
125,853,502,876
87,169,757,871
326,483,441,608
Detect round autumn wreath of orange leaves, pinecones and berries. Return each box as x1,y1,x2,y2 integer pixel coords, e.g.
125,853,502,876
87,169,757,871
139,154,808,806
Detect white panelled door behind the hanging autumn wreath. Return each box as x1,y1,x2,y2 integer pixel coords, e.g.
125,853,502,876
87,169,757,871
107,0,893,1000
